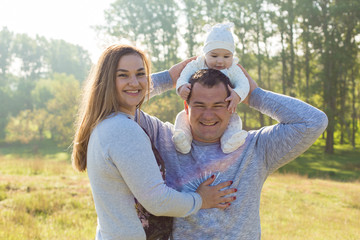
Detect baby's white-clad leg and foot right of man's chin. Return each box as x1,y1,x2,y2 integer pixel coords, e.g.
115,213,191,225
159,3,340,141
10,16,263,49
220,113,248,153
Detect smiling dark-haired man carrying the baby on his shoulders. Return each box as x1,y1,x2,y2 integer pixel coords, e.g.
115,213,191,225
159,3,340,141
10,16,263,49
140,66,327,240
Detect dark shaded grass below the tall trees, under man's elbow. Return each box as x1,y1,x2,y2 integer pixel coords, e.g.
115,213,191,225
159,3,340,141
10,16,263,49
278,140,360,182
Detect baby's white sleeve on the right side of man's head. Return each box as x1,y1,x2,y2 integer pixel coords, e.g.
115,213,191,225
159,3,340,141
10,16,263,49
228,63,250,102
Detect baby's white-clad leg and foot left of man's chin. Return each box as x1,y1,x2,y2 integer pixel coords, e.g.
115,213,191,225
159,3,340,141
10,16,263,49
172,110,192,154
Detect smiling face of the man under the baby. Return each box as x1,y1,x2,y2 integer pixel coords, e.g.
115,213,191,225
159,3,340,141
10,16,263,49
185,83,231,143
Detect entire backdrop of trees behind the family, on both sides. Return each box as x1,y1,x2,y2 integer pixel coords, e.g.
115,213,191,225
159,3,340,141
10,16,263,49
0,0,360,153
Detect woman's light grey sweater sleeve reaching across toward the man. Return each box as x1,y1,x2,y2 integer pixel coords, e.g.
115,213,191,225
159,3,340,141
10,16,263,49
108,120,202,217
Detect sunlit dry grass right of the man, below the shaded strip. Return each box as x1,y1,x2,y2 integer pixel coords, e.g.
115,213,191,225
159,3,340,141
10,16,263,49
260,174,360,240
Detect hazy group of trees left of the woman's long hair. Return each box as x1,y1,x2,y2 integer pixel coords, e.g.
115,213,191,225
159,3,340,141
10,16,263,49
0,27,92,146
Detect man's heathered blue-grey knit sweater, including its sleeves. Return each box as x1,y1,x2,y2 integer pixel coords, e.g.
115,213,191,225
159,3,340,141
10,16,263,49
140,72,327,240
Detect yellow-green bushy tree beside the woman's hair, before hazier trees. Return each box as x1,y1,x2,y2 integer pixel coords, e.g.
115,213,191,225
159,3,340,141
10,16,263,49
6,73,80,146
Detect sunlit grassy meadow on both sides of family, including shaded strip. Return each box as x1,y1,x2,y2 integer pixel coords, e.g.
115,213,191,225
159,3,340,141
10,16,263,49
0,140,360,240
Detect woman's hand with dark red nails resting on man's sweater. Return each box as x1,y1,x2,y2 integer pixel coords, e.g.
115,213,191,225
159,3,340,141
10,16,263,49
196,175,237,209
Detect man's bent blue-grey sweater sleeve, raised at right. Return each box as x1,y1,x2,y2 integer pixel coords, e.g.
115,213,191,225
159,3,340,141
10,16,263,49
250,88,328,173
